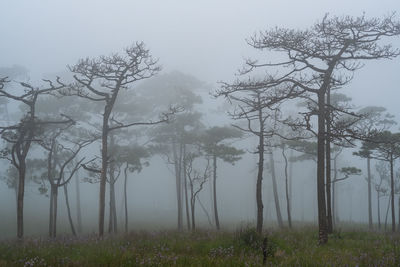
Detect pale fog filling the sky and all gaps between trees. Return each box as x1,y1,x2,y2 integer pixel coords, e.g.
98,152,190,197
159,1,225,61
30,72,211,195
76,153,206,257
0,0,400,239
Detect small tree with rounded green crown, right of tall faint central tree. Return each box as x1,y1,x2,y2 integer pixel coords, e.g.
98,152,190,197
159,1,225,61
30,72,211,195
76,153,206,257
200,126,244,230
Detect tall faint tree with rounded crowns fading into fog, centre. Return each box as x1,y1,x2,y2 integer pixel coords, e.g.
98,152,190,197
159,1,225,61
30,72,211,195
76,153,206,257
144,71,205,230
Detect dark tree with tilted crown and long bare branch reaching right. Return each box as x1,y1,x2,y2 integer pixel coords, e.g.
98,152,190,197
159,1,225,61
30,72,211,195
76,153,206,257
64,43,173,236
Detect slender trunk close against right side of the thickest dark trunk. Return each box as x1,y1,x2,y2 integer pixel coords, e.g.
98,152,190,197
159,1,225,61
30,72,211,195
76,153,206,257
325,87,333,233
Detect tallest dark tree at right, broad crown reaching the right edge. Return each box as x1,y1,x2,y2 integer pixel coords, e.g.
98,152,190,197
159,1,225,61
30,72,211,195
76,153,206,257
222,14,400,244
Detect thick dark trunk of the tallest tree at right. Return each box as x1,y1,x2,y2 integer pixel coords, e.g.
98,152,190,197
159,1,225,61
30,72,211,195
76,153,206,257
317,89,328,245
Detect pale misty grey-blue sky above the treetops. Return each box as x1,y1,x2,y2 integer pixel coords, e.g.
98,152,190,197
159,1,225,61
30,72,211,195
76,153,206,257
0,0,400,113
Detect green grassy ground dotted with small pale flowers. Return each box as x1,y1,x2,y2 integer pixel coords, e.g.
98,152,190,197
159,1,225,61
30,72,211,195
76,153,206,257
0,227,400,266
